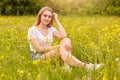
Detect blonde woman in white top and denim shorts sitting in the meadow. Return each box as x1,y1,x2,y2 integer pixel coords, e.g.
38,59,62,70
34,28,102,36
28,7,101,70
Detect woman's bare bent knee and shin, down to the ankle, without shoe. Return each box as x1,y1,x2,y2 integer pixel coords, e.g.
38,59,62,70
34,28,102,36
59,38,86,67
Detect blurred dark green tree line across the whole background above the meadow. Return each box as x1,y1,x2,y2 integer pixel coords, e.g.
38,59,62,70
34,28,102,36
0,0,120,16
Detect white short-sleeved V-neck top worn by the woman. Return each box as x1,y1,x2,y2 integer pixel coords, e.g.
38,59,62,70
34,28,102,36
28,26,56,51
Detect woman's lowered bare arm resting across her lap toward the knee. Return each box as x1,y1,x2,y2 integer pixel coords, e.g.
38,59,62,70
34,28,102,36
30,38,59,53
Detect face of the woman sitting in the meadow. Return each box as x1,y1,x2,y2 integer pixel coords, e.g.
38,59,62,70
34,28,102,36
41,10,52,25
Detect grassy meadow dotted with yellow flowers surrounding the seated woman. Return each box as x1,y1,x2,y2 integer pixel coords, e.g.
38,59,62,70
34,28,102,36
0,16,120,80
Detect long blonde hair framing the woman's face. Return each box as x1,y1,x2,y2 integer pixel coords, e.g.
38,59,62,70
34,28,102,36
35,7,53,27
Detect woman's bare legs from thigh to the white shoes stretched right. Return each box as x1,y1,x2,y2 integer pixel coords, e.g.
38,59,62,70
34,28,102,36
42,38,103,70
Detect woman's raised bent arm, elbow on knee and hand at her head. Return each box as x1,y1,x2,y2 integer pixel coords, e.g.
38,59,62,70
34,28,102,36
54,13,67,38
